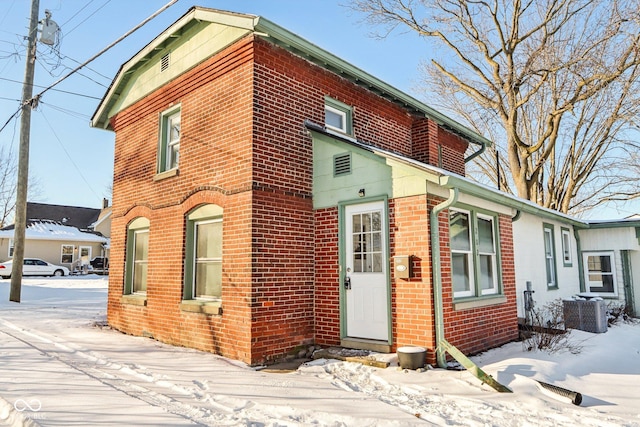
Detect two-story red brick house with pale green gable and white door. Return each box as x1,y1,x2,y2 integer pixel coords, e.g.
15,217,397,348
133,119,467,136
92,7,518,364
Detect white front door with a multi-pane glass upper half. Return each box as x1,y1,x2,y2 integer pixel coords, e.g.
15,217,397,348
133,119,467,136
343,202,389,341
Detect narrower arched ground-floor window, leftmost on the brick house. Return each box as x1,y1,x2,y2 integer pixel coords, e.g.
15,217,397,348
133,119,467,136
124,218,149,295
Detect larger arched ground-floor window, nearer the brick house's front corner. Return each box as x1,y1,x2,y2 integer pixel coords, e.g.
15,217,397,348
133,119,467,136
184,205,223,300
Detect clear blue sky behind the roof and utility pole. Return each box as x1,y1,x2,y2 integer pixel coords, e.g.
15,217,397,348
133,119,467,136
0,0,637,219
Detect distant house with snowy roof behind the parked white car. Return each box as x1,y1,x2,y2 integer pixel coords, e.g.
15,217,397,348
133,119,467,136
0,202,108,271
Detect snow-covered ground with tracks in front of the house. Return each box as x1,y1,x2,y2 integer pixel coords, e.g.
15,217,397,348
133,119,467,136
0,276,640,426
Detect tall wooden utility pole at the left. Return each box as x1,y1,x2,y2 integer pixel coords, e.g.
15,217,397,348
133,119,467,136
9,0,40,302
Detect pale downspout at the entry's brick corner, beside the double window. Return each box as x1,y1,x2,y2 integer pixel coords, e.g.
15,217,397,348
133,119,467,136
429,188,458,368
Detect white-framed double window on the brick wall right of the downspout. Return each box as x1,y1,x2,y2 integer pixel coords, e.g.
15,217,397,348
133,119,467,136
449,209,498,298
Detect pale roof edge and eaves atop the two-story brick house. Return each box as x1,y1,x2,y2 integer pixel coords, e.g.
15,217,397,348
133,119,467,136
91,6,492,150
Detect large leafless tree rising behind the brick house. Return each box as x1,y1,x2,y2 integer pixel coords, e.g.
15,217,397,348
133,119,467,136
351,0,640,213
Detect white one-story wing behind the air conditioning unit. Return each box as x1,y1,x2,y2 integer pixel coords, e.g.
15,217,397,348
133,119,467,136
513,206,640,321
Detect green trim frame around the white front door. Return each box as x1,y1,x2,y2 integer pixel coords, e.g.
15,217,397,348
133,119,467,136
338,195,393,345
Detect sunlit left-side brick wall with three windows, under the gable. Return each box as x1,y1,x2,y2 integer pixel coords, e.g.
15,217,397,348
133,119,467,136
108,38,254,363
